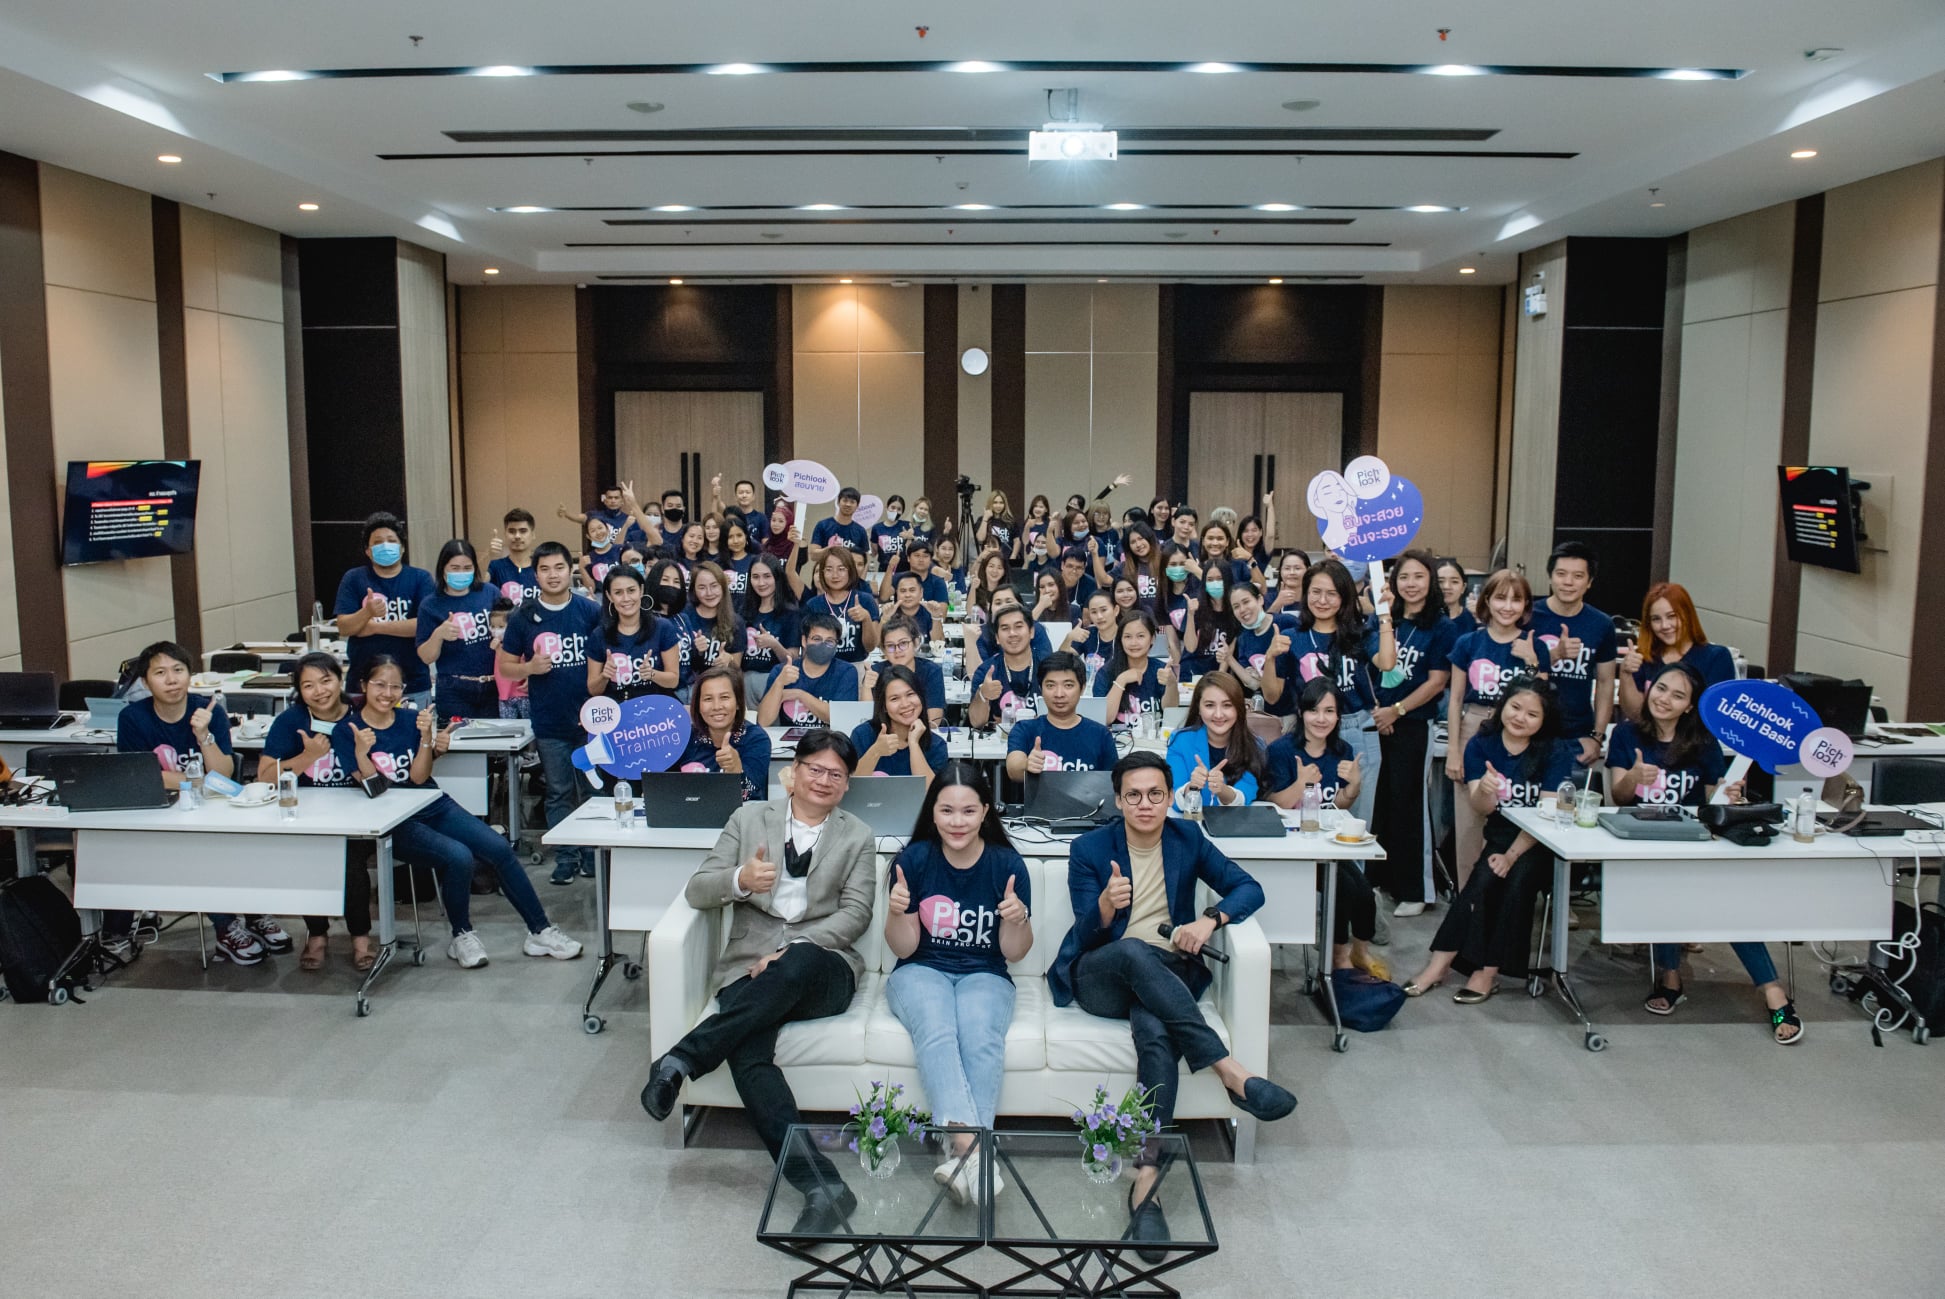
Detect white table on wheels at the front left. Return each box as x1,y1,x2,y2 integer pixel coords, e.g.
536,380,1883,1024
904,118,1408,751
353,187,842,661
0,788,440,1017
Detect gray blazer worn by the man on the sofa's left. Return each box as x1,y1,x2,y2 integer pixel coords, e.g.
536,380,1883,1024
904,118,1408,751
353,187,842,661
685,795,877,986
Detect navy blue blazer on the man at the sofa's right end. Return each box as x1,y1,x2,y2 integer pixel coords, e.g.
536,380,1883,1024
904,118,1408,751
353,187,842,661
1046,817,1262,1005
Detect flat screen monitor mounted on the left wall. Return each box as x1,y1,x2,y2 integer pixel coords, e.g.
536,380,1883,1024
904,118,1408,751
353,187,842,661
60,461,202,564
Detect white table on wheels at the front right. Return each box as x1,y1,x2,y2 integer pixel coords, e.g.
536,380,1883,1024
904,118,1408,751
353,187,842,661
1505,807,1945,1050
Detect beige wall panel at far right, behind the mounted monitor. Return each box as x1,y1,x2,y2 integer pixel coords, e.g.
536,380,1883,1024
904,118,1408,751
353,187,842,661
1797,159,1945,716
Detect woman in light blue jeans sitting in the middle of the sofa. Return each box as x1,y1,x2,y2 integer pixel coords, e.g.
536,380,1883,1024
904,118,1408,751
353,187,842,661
885,760,1033,1204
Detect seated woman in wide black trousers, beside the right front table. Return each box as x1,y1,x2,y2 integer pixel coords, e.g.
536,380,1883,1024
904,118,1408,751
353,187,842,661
1404,680,1579,1005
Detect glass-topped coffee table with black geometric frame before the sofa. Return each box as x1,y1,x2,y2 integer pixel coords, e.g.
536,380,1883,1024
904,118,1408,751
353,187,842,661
757,1124,1218,1297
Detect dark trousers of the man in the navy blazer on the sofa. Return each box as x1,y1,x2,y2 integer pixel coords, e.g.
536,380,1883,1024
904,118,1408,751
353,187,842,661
1074,937,1229,1128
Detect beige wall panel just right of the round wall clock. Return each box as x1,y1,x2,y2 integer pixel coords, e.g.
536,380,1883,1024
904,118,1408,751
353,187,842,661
1019,284,1159,513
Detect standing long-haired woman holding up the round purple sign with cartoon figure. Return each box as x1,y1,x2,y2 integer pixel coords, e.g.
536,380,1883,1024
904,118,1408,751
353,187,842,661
1262,560,1398,825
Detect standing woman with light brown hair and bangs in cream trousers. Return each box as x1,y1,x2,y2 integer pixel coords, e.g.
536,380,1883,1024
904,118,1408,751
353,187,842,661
1445,568,1546,887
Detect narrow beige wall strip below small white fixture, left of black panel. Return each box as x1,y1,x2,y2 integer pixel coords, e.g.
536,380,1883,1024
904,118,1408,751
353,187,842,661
1501,239,1568,583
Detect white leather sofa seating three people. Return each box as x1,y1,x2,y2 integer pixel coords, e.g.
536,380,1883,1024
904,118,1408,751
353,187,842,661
648,852,1270,1163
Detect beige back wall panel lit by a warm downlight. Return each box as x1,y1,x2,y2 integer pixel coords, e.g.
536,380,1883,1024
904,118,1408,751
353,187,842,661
790,284,926,517
